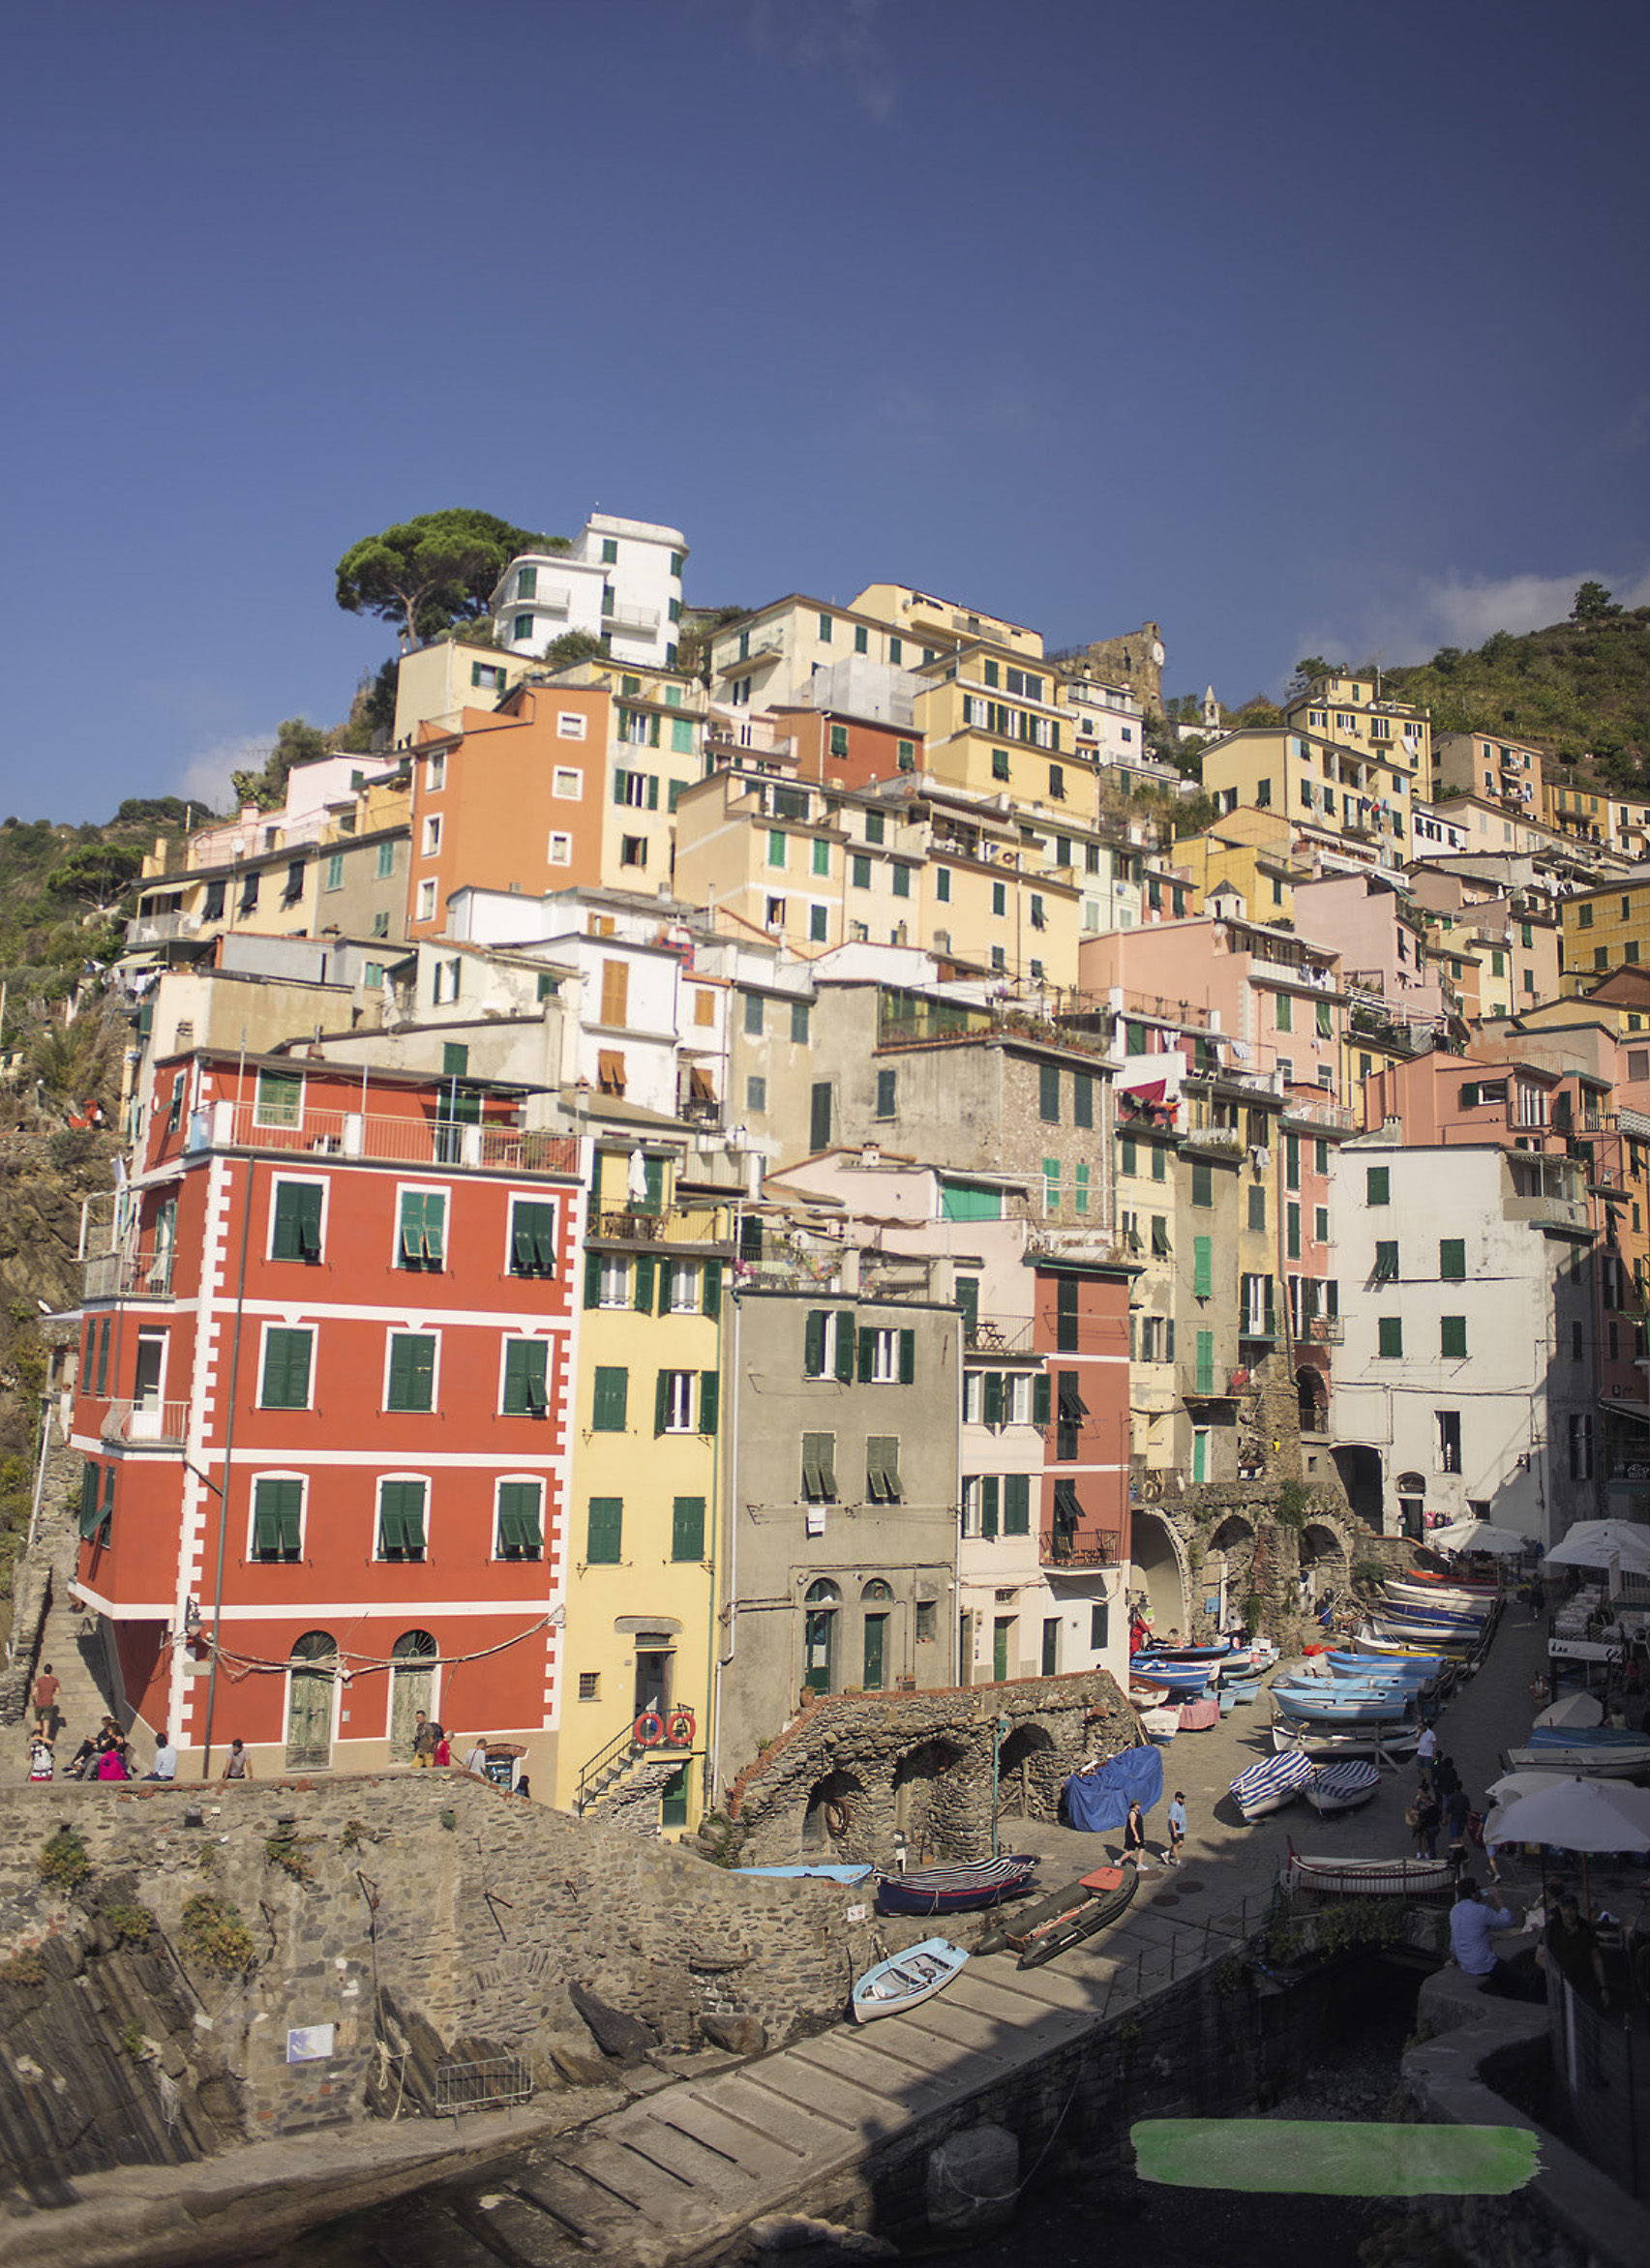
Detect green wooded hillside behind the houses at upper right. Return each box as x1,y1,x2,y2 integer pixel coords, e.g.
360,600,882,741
1360,582,1650,790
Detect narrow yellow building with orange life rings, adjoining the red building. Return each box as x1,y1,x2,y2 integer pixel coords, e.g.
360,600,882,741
556,1136,734,1833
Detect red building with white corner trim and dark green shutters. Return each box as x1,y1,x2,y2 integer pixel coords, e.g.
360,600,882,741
75,1050,584,1785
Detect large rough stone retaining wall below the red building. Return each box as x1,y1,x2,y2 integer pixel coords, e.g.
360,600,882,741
0,1772,867,2134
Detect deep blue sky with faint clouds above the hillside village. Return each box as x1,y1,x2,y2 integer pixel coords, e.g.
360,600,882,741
0,0,1650,819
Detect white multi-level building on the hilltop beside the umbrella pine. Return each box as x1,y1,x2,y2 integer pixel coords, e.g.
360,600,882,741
493,513,688,669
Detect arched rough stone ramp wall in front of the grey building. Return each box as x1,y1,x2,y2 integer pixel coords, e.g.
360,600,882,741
704,1669,1139,1866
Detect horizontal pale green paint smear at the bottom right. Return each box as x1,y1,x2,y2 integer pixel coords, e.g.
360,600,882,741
1130,2118,1539,2197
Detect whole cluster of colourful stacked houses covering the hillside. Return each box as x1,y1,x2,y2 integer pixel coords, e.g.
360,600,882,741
29,515,1650,1844
